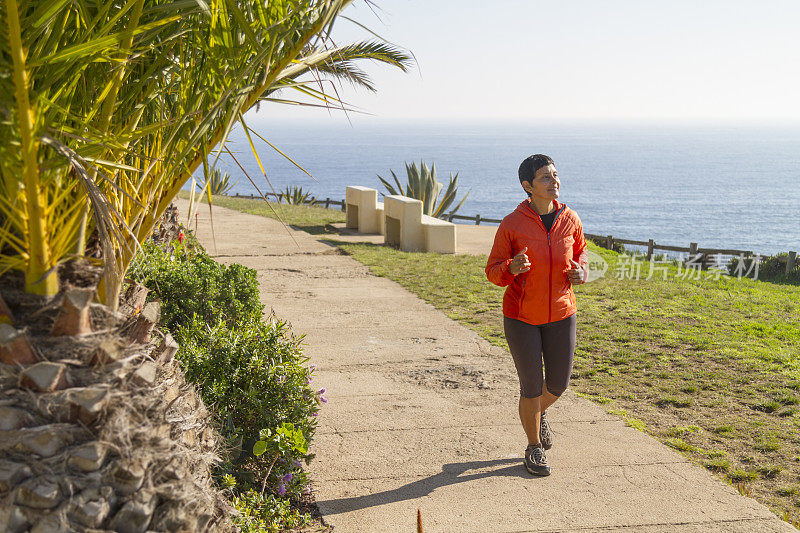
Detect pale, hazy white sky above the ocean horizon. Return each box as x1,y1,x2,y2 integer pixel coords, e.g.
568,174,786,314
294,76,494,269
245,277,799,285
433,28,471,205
257,0,800,123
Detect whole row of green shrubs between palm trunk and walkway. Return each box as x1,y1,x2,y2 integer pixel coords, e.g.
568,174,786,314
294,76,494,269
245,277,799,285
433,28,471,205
130,237,326,532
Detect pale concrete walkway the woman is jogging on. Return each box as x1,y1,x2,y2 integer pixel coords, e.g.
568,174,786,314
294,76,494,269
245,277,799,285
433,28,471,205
179,202,795,533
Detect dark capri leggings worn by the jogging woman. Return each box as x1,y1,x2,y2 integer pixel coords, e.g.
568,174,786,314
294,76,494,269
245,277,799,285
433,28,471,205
503,314,576,398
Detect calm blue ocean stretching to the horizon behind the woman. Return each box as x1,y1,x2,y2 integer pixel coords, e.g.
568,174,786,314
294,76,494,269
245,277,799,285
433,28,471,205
195,121,800,254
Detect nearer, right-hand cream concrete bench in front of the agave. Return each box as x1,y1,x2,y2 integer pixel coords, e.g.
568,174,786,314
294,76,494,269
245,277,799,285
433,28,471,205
384,195,456,254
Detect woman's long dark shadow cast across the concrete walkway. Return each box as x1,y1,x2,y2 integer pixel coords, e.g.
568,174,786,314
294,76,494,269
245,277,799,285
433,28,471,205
317,458,532,515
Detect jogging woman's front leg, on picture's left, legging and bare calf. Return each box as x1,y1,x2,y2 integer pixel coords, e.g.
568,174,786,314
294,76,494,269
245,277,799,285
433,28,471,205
503,317,552,444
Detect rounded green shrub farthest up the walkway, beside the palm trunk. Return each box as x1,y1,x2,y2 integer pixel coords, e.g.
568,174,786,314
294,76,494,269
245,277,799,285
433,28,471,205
129,242,264,332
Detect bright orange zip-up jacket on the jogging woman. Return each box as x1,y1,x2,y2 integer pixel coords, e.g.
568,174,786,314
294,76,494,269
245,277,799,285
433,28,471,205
486,200,588,325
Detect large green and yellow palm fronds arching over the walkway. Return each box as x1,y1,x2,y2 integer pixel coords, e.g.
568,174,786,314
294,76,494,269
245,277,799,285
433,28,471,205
0,0,409,307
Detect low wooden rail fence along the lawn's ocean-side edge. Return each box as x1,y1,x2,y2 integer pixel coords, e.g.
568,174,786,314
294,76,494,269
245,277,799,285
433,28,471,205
232,192,798,274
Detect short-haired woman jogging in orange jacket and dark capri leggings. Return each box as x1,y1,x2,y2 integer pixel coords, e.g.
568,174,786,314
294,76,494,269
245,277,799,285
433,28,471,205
486,154,588,476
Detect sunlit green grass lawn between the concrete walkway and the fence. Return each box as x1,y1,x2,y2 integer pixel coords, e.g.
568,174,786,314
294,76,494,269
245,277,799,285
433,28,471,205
194,194,800,524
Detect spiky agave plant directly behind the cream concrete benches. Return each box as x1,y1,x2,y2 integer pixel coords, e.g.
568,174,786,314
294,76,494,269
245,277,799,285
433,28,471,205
378,161,470,218
